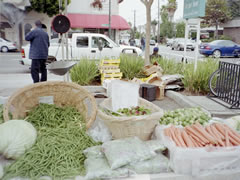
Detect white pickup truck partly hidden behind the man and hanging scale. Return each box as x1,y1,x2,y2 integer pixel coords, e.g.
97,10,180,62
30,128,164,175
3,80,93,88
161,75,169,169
20,33,142,66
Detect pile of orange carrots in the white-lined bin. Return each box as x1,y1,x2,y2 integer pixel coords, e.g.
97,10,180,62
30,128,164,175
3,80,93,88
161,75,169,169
164,122,240,148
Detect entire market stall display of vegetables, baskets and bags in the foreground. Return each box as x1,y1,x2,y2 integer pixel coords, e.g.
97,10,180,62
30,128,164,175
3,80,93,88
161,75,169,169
0,82,240,180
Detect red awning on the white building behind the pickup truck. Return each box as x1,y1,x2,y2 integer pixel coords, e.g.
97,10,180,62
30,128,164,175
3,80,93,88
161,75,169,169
68,14,130,30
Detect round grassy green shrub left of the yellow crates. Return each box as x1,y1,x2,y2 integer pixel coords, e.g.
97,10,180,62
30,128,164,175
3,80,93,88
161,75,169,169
70,58,99,85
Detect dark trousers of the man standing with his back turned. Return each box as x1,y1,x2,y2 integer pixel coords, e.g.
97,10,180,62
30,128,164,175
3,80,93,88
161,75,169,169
31,59,47,83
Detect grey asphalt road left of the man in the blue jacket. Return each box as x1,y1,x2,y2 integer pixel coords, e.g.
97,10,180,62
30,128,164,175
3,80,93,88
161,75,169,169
0,52,30,74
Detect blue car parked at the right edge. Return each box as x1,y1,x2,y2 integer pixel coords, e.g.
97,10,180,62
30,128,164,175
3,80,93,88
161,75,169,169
199,40,240,58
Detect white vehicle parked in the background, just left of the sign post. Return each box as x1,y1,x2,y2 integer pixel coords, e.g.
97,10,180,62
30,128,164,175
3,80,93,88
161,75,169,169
172,38,195,51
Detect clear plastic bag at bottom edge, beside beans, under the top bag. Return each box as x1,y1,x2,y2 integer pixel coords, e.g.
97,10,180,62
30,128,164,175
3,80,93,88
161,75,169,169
84,156,129,180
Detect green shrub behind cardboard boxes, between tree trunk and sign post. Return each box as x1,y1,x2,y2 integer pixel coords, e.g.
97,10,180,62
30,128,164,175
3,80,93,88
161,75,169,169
152,57,184,74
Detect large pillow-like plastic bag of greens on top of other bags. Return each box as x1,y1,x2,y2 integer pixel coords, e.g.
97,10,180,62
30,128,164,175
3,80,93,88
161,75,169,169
102,137,156,169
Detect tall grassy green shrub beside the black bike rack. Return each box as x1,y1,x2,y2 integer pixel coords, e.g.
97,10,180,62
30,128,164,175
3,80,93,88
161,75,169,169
183,58,218,94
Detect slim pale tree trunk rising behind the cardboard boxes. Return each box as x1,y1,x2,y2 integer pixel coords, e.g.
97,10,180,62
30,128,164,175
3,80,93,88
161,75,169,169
145,3,152,65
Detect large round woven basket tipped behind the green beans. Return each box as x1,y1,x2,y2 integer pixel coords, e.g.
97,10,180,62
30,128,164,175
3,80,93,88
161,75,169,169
3,81,97,128
